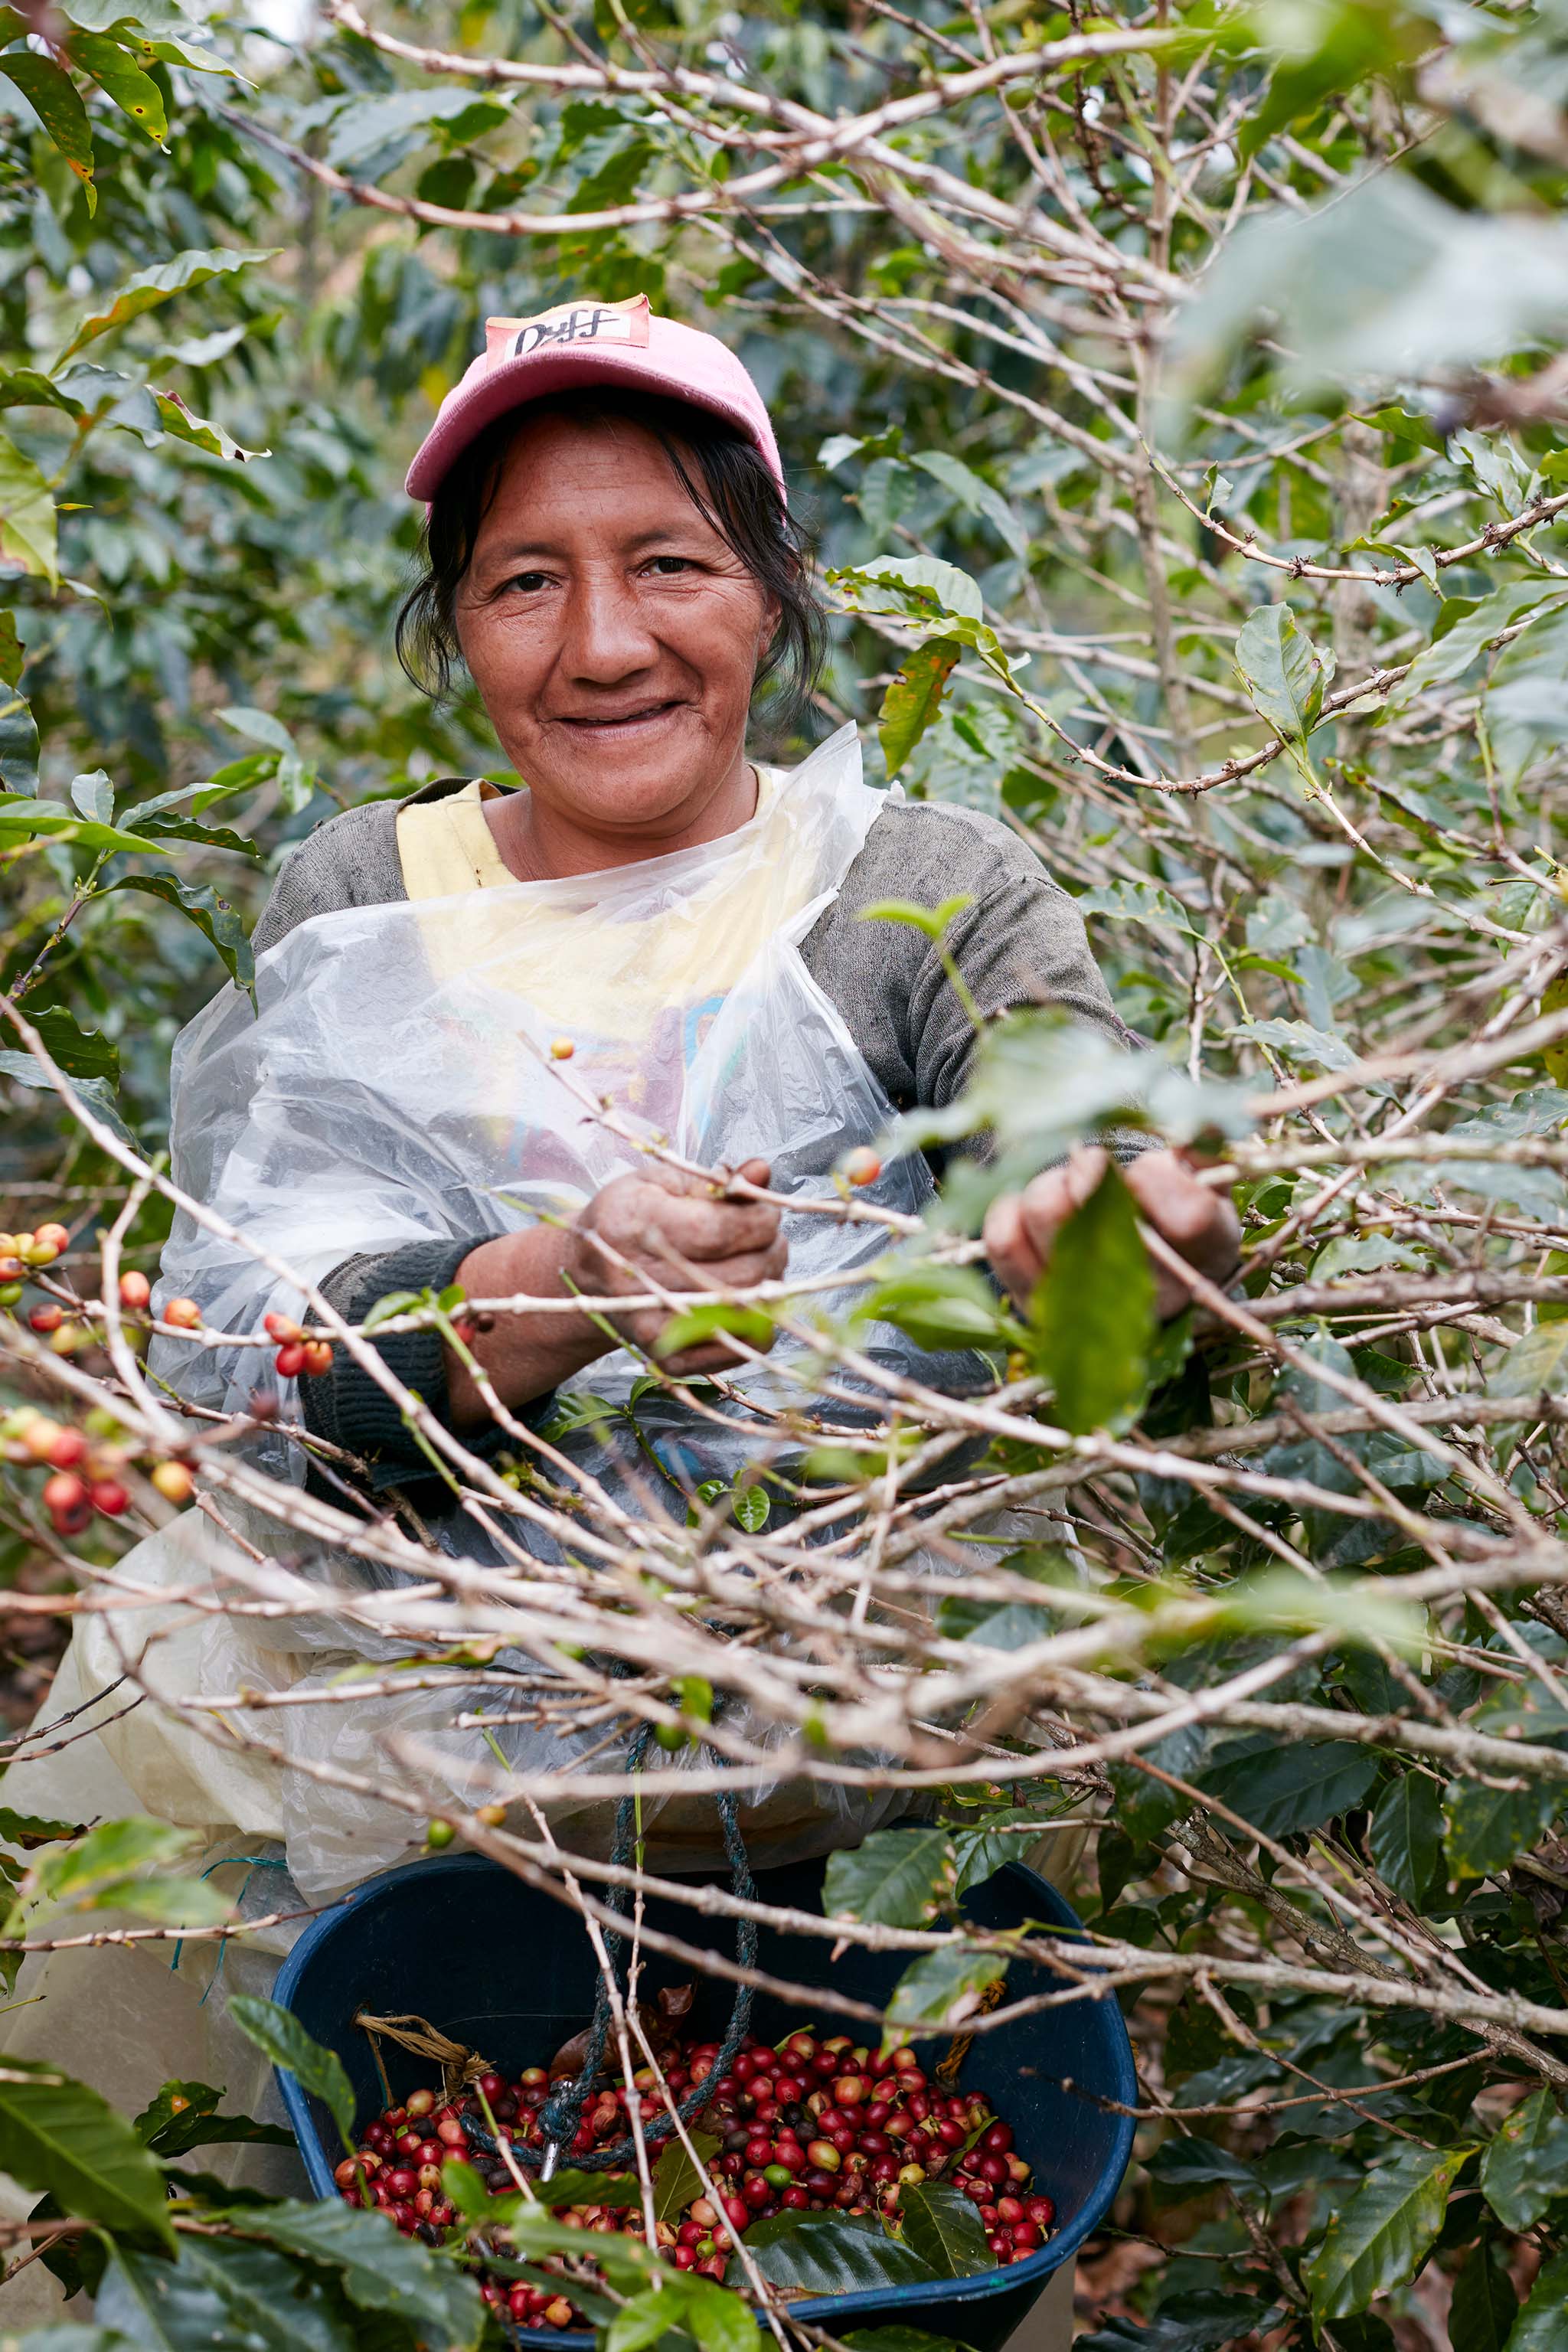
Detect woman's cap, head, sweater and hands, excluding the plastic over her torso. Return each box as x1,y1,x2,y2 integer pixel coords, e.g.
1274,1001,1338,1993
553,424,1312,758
232,296,1236,1487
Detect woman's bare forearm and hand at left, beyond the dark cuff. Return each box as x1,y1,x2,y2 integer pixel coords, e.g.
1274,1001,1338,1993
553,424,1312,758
446,1159,790,1430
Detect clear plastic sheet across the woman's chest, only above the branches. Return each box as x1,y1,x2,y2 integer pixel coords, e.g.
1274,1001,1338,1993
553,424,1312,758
158,727,982,1475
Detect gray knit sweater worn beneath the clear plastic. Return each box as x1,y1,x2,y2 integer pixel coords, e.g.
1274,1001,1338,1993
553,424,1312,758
254,779,1131,1487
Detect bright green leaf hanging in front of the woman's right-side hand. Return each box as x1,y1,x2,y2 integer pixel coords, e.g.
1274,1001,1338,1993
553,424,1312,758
1030,1162,1155,1437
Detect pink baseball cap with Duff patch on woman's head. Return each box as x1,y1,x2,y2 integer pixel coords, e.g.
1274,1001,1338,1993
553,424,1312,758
404,294,786,498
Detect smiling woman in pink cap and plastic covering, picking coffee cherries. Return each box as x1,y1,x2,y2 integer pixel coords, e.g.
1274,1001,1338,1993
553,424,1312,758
11,301,1236,1909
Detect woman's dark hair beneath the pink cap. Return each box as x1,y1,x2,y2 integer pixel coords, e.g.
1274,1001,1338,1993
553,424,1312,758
395,388,828,737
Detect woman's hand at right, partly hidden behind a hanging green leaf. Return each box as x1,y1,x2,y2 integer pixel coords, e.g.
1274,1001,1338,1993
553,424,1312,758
985,1145,1241,1317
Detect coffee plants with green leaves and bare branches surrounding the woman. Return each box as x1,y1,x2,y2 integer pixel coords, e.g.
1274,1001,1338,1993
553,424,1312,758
0,0,1568,2352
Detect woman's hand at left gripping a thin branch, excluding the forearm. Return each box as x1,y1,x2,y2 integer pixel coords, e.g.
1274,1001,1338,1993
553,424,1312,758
562,1159,790,1378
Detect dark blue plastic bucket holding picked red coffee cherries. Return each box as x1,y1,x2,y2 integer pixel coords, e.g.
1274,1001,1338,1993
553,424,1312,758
273,1854,1135,2352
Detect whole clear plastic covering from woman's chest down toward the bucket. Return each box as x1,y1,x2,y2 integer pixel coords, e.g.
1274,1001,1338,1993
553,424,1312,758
144,729,982,1889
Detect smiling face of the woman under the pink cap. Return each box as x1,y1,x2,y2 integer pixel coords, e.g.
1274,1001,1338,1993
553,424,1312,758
454,414,776,875
